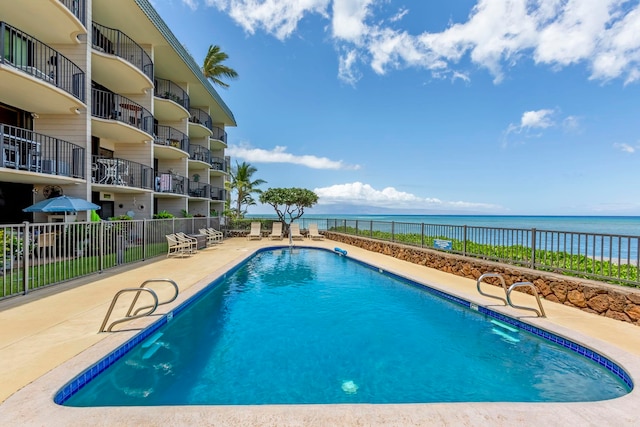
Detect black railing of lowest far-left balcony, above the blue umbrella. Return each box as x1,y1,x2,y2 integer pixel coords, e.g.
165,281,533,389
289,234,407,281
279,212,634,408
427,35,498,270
0,124,85,179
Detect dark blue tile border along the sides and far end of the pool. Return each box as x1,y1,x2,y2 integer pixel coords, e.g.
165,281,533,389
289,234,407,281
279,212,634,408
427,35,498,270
53,246,634,405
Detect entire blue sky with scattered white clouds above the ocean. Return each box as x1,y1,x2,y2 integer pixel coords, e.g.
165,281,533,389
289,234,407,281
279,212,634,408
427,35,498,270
152,0,640,215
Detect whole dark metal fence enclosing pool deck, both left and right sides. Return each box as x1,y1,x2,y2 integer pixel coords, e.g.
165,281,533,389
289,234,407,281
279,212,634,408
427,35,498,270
0,217,640,299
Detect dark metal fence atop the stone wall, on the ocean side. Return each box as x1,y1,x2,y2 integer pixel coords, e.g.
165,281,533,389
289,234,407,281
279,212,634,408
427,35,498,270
299,218,640,287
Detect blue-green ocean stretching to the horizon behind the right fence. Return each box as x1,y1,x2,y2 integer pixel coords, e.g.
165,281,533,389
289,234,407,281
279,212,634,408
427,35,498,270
247,214,640,274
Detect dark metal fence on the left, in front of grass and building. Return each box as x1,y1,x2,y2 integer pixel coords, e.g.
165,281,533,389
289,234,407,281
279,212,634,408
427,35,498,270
0,217,220,299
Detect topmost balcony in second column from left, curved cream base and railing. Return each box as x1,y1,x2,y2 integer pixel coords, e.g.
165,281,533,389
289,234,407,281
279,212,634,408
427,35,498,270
91,22,153,93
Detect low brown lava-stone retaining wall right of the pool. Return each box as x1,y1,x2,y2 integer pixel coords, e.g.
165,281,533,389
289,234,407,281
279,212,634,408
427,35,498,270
324,231,640,326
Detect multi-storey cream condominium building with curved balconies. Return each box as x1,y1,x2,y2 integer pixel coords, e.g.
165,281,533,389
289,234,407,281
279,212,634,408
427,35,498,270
0,0,236,224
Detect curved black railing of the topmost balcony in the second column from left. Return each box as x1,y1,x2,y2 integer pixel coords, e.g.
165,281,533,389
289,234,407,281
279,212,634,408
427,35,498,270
92,22,153,81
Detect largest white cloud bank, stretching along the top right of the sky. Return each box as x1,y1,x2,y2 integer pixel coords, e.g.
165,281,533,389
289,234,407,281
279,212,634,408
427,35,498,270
199,0,640,84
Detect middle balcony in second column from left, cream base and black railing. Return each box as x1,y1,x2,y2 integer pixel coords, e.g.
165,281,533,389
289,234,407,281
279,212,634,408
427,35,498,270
91,88,153,142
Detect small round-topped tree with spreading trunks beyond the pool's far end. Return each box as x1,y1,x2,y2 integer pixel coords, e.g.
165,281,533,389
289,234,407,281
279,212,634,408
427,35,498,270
260,188,318,232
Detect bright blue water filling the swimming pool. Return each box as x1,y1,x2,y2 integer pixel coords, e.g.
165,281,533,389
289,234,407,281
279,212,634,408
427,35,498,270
56,248,631,406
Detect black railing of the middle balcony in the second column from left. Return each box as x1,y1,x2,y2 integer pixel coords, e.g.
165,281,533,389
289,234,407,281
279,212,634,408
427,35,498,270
91,88,153,134
